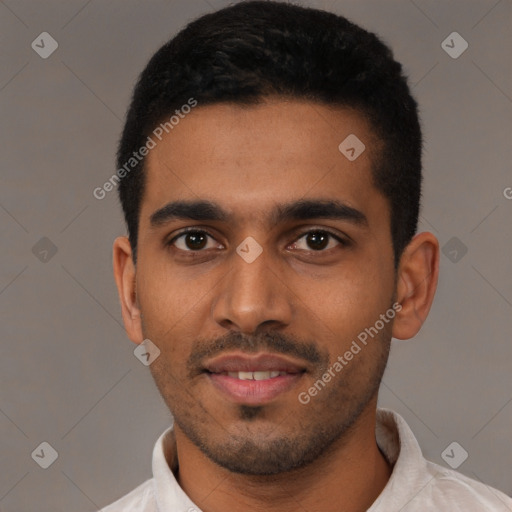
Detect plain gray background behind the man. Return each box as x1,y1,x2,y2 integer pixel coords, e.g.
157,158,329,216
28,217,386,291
0,0,512,512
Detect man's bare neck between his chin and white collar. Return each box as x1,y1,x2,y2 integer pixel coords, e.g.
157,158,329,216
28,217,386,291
171,404,391,512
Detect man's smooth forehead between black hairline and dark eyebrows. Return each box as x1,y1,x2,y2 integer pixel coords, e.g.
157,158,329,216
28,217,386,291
141,100,383,226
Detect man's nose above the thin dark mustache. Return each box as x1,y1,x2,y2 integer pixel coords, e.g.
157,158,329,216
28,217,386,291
212,242,293,334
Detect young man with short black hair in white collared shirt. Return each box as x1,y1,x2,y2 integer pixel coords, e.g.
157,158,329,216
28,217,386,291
104,2,512,512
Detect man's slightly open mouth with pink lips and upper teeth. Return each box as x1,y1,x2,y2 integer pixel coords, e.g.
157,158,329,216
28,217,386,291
203,353,306,405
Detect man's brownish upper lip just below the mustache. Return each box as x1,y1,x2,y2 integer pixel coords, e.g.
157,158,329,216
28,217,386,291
204,353,306,373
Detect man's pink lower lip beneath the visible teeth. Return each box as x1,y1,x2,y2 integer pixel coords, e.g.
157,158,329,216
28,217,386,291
206,373,303,405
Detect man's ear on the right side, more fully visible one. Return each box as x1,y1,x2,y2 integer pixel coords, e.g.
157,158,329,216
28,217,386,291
392,232,439,340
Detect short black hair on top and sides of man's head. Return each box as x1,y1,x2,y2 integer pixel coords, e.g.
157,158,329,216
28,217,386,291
117,1,422,269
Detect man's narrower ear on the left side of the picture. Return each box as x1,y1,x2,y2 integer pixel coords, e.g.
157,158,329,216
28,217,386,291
113,236,144,344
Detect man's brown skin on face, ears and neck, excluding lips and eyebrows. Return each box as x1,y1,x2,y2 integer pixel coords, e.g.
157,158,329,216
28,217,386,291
114,98,439,512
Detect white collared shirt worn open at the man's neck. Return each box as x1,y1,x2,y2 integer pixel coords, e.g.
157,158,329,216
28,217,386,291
101,409,512,512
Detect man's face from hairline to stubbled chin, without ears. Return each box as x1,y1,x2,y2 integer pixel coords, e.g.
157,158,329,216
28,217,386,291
119,100,396,475
